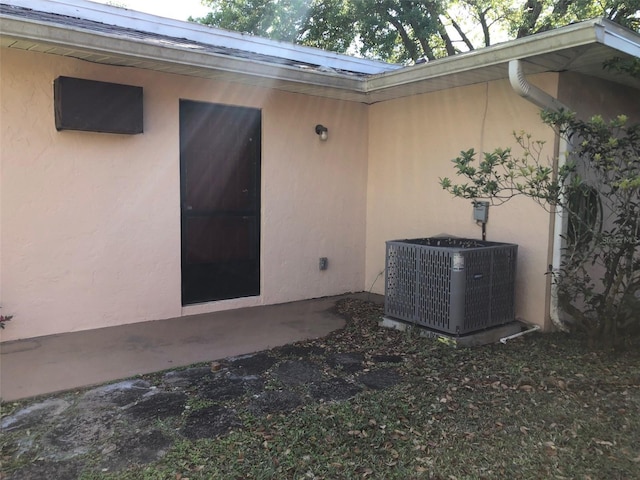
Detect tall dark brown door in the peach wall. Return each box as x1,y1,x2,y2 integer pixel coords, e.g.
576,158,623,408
180,100,261,305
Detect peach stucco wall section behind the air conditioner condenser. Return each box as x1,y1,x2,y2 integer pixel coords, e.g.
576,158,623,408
366,74,557,326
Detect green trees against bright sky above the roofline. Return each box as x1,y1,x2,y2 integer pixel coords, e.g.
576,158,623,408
191,0,640,62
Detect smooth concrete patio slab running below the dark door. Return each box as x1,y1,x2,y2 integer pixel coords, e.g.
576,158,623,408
0,294,379,401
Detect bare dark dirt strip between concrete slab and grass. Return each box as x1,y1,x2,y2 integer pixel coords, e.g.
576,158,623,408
0,302,403,480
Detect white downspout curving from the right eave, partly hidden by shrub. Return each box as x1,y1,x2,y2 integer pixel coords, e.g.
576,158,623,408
509,60,569,331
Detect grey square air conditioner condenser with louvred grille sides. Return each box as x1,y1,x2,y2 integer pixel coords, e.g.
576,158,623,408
385,237,518,335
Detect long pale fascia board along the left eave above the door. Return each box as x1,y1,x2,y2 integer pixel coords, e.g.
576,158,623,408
0,16,364,93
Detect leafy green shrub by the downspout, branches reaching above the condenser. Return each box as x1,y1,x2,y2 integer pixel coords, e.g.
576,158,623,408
440,112,640,344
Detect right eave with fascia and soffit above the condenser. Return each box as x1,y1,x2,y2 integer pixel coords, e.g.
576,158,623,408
367,20,640,103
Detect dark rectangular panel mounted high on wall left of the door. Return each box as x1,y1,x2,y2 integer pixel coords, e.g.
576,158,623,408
53,77,143,134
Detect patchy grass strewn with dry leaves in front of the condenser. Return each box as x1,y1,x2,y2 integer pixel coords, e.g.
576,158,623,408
5,300,640,480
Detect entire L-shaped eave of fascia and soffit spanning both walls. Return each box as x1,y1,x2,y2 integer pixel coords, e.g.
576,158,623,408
0,4,640,104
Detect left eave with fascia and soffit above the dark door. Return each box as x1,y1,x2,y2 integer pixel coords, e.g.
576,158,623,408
0,4,376,101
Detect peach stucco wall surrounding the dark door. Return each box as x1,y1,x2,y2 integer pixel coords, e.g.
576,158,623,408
0,49,367,341
